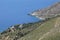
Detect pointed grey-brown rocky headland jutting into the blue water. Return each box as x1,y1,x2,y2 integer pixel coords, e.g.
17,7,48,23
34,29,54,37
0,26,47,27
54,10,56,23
30,2,60,20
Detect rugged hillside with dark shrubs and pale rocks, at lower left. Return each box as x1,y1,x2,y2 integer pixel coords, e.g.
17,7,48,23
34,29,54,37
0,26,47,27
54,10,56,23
0,21,42,40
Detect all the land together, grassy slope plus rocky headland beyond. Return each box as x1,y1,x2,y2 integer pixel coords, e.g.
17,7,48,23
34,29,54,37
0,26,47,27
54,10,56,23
0,2,60,40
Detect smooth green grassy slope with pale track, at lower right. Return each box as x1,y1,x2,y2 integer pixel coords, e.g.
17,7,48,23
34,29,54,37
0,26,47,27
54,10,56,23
19,17,60,40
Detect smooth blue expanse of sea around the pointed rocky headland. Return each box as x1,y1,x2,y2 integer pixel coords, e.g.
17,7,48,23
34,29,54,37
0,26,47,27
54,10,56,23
0,0,60,32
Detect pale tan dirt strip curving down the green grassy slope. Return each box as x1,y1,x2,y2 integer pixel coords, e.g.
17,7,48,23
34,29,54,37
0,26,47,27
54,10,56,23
39,18,60,40
